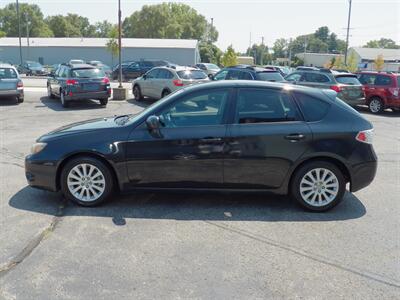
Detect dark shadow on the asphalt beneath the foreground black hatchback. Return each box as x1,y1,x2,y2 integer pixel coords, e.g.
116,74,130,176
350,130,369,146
9,186,366,225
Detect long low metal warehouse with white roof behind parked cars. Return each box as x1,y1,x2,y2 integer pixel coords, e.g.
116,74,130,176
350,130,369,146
0,38,200,65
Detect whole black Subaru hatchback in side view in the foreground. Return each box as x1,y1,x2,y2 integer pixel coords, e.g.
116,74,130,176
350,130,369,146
25,81,377,211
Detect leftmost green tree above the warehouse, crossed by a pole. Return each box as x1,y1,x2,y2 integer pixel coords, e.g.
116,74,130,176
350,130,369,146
0,3,53,37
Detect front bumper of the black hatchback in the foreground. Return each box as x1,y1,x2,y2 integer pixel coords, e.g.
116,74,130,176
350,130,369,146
25,155,58,192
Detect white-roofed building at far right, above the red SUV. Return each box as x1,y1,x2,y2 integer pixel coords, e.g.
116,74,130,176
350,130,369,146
349,47,400,72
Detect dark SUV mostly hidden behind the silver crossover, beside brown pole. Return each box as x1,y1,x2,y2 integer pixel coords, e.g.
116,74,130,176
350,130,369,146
112,60,173,81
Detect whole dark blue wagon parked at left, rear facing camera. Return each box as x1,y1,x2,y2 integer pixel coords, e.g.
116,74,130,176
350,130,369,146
47,64,111,107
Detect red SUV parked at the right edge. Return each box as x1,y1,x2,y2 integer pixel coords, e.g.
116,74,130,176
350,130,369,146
357,72,400,114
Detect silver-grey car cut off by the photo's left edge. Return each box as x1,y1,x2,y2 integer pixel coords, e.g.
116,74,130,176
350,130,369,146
0,64,24,103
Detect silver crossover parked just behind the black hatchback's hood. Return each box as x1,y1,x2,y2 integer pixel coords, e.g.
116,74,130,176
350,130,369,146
132,66,210,100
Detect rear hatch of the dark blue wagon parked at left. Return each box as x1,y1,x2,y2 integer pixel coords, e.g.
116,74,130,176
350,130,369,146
67,68,110,93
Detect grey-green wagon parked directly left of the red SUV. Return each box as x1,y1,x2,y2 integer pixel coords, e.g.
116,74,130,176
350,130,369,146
285,69,365,106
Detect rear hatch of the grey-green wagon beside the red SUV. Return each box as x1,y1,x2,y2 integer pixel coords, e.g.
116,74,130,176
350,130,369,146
335,74,365,100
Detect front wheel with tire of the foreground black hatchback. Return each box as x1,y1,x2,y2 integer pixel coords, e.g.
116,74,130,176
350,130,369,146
60,157,114,207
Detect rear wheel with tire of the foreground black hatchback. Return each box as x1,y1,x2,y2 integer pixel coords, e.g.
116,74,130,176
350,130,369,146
291,161,346,211
